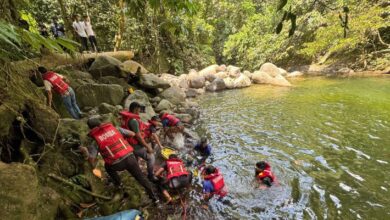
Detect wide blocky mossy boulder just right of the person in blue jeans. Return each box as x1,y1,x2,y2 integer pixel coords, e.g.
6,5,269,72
76,84,125,108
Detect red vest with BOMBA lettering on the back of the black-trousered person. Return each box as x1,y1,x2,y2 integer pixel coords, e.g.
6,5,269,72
89,123,133,165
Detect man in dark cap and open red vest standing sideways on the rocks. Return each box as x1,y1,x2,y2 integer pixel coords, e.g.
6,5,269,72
119,102,157,181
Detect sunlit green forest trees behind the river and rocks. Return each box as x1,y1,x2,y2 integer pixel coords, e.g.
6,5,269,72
0,0,390,74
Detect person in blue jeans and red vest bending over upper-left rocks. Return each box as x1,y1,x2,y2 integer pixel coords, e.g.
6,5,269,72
38,66,82,119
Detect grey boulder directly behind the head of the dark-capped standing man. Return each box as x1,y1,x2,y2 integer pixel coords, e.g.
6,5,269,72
123,90,156,121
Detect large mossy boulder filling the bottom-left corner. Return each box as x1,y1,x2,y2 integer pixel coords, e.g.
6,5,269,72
0,162,40,219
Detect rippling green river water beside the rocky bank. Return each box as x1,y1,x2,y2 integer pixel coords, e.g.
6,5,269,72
192,77,390,219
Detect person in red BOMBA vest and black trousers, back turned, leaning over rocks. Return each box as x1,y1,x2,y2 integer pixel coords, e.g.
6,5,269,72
87,117,158,202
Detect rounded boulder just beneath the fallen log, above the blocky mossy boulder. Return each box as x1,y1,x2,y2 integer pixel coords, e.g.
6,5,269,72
88,56,126,78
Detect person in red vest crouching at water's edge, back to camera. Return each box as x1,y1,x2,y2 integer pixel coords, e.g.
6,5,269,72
155,154,192,203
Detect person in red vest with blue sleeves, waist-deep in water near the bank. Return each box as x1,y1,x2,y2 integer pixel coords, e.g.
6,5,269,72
202,165,227,200
